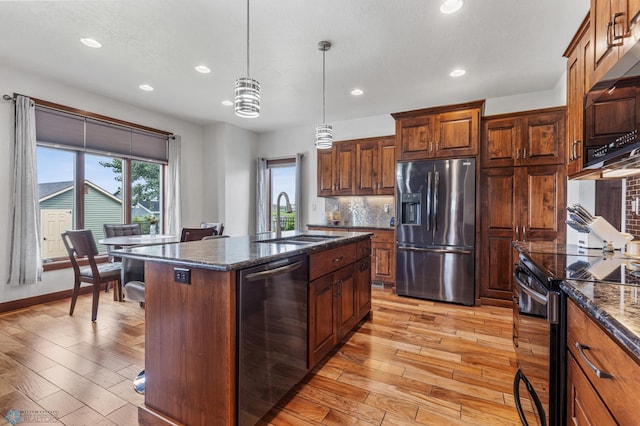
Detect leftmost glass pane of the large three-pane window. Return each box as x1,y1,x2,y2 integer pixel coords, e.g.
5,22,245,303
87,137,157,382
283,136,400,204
36,146,76,262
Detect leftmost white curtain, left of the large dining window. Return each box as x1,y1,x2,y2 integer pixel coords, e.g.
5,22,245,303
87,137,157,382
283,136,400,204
7,95,42,285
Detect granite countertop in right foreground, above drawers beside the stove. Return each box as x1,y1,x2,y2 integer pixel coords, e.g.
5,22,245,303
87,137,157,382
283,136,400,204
560,280,640,359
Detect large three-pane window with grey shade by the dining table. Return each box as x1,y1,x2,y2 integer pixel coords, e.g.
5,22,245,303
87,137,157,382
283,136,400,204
36,104,168,262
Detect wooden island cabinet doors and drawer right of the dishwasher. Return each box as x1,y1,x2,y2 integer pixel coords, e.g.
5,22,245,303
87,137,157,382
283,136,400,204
308,242,371,368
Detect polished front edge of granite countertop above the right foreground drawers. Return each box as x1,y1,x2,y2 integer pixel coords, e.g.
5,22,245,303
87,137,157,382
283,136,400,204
560,280,640,360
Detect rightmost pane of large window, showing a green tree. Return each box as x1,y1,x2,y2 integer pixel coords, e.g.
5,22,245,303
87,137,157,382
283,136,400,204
131,161,162,234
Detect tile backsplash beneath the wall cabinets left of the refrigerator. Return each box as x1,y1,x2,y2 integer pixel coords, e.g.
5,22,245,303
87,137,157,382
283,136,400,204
325,196,396,227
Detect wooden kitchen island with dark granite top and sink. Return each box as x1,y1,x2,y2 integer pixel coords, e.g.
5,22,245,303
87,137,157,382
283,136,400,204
113,232,371,425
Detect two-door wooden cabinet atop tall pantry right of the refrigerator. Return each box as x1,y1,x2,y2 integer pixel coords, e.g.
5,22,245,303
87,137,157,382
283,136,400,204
482,107,566,167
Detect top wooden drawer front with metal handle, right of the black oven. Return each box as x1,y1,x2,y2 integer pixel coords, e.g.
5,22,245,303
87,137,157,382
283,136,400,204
567,300,640,424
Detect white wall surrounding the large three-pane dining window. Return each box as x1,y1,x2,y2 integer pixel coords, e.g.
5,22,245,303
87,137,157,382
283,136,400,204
0,66,204,302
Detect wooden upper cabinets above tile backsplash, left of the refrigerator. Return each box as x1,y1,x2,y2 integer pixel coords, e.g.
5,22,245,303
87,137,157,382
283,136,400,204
318,136,395,197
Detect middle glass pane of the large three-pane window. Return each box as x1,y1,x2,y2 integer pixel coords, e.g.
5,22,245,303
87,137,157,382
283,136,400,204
83,154,124,253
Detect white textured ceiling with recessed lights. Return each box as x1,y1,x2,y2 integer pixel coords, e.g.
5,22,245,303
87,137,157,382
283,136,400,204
0,0,589,132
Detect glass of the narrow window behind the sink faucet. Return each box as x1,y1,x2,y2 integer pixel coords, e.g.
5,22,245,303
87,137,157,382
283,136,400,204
267,159,296,231
